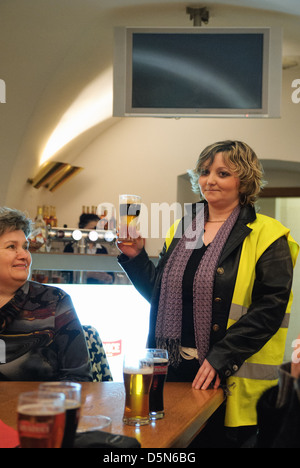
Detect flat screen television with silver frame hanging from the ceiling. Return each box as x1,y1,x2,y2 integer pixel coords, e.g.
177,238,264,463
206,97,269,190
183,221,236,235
113,27,282,117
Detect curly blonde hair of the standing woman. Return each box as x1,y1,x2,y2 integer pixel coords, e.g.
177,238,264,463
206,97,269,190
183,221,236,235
188,140,265,205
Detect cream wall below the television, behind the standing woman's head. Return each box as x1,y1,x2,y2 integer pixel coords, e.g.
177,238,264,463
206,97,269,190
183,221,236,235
6,66,300,255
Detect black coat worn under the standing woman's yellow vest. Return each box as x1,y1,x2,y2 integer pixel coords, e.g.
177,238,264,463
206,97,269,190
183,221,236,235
119,206,293,378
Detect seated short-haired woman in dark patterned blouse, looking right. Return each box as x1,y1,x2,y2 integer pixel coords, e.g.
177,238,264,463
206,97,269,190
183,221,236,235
0,207,92,381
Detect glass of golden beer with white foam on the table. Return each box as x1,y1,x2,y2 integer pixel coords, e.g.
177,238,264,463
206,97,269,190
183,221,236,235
123,352,153,426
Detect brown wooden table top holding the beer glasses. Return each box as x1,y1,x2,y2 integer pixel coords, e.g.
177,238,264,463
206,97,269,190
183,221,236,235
0,382,224,448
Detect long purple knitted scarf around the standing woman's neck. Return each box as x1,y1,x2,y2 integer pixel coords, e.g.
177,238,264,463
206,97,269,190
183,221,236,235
155,205,240,366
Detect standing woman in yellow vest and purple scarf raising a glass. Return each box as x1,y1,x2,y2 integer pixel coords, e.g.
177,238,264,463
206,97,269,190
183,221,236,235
117,140,299,447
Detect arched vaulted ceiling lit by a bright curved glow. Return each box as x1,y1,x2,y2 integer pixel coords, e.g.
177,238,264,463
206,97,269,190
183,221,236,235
0,0,300,208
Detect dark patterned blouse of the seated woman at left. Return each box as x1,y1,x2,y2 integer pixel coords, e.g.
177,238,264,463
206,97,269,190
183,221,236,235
0,281,92,381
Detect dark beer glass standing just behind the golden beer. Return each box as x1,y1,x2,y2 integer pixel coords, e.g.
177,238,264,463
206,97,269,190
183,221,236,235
147,349,169,419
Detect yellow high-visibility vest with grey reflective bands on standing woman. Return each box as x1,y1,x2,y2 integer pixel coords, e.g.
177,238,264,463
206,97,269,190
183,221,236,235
166,207,299,427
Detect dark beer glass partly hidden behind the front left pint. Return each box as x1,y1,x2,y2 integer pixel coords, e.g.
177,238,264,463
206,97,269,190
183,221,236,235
39,382,81,448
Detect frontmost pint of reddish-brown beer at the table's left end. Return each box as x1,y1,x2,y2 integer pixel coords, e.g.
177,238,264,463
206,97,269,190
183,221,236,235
17,391,65,448
